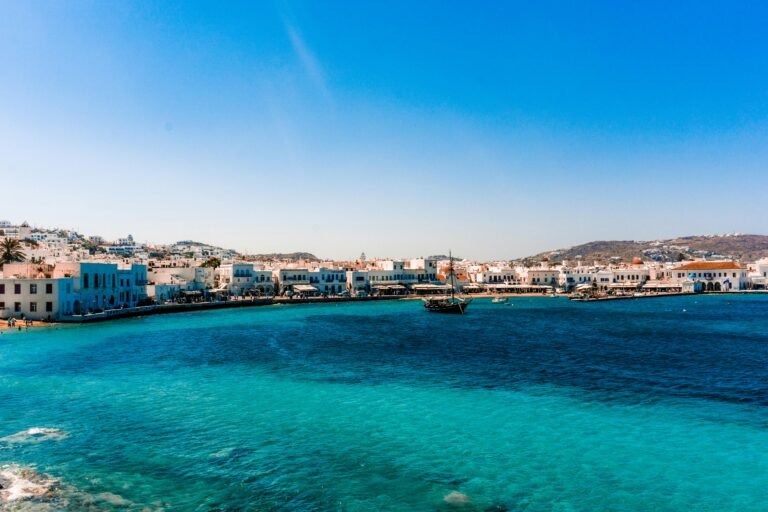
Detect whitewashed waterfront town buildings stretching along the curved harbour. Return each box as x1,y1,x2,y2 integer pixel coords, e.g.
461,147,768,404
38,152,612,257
0,222,768,321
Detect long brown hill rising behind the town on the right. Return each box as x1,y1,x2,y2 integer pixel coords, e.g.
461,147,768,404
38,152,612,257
522,234,768,264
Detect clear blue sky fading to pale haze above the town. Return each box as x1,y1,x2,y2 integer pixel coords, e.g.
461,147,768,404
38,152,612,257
0,0,768,259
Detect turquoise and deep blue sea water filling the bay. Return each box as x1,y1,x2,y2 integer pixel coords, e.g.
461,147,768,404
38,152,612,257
0,295,768,512
